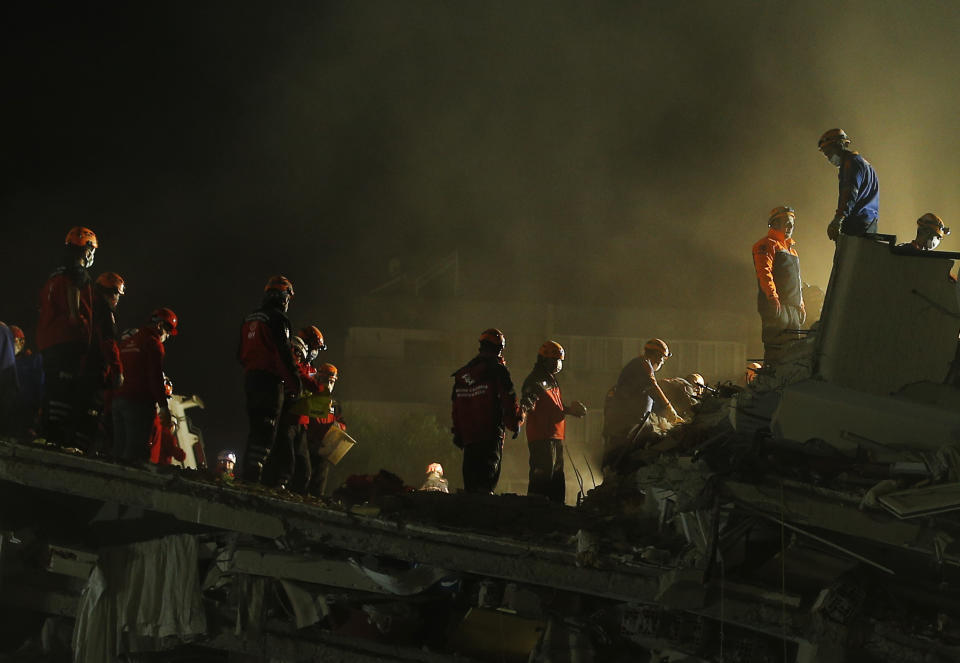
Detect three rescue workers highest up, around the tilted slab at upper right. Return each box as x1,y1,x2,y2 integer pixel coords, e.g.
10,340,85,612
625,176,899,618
748,129,950,360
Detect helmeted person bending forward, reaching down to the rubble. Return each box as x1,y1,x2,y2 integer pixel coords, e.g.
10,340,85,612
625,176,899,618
602,338,683,473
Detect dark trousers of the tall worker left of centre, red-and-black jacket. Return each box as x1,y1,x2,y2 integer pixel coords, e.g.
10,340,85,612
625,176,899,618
242,371,283,482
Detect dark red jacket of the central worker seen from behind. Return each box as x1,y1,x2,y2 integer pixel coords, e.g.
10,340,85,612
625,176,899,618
451,355,523,445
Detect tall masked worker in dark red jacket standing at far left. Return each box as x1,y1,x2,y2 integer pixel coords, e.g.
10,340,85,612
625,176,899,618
37,226,99,446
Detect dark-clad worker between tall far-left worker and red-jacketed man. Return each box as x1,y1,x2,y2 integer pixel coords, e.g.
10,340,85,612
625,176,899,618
76,272,126,453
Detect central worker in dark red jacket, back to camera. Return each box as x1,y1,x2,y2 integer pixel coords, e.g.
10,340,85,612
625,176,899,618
451,329,523,494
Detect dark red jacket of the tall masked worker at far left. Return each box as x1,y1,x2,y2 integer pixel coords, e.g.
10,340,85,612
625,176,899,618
37,267,93,352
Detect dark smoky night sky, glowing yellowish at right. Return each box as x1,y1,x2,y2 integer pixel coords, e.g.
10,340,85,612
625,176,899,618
0,0,960,452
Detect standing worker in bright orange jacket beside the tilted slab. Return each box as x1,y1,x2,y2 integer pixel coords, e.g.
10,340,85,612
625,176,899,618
753,206,807,362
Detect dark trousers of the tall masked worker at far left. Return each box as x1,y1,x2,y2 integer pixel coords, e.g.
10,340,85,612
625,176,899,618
41,343,86,446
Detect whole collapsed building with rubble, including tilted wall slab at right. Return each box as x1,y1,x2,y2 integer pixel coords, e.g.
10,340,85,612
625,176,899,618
0,236,960,663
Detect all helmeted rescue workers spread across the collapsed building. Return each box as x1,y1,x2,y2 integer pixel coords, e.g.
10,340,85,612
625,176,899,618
0,129,950,503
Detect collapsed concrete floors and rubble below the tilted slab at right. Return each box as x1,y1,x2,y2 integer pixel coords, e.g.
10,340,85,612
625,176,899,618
0,416,960,662
